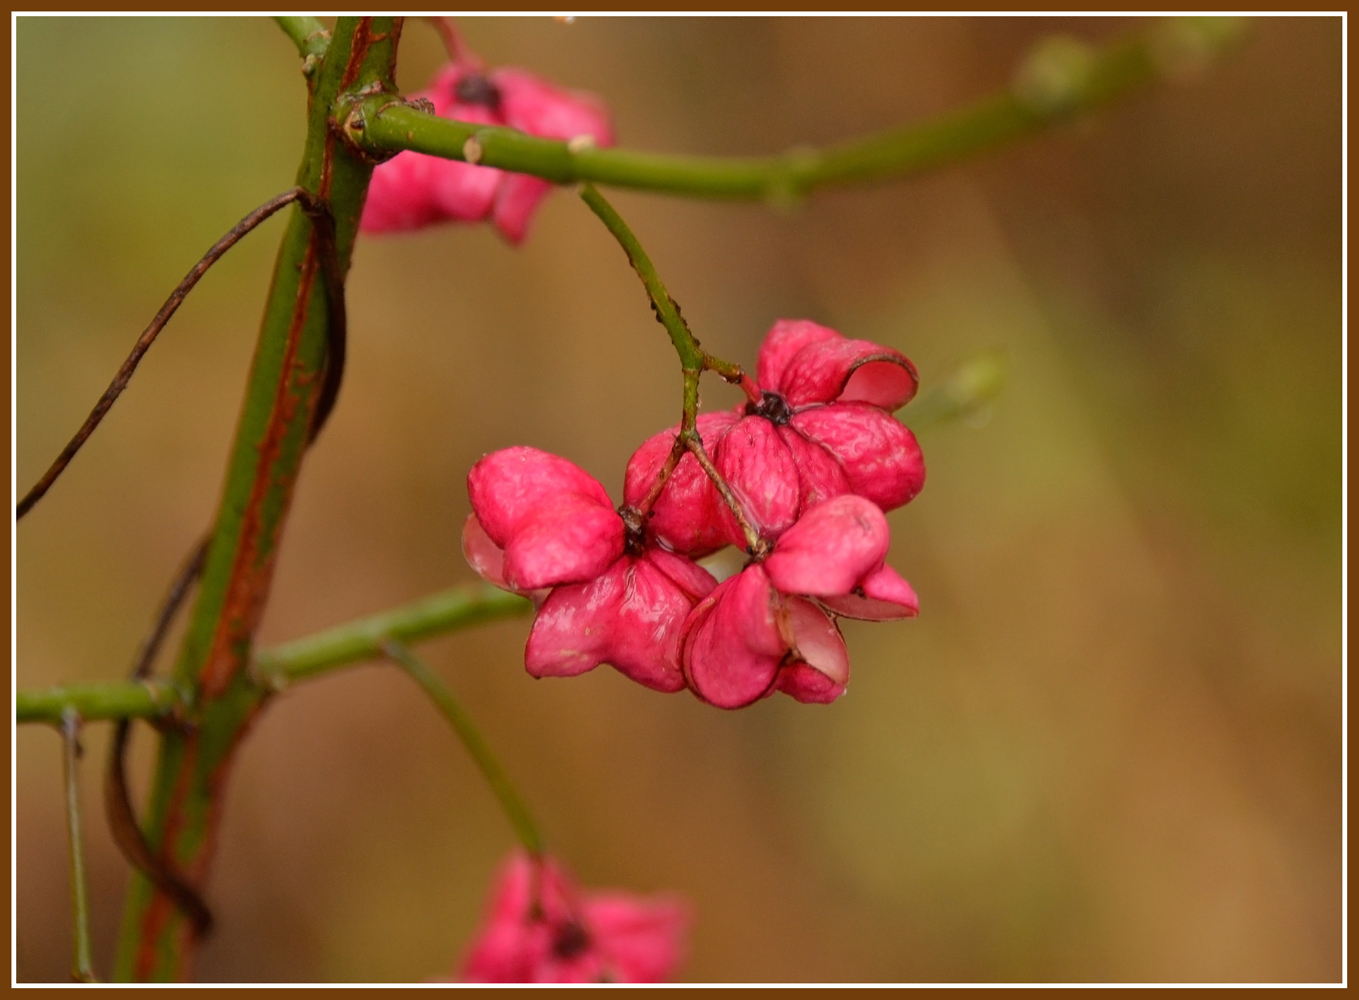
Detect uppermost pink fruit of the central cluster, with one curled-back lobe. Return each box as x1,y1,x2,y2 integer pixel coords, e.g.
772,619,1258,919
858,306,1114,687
624,319,925,558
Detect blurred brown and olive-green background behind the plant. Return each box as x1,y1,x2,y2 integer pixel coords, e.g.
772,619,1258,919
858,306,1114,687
16,18,1341,981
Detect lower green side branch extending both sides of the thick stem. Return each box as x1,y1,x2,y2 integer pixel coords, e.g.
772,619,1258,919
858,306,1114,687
15,583,533,726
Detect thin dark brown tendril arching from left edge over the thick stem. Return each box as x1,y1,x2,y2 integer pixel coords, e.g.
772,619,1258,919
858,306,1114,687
15,188,345,520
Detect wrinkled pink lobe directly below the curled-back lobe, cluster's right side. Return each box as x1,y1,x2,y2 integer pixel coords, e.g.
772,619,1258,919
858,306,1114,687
790,402,925,511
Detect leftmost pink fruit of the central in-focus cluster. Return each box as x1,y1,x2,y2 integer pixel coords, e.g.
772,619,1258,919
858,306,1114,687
462,447,716,692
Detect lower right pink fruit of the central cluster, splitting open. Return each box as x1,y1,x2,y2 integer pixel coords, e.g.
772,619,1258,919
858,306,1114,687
681,495,919,708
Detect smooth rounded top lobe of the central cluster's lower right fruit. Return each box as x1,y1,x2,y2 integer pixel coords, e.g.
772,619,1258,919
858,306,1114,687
764,493,892,596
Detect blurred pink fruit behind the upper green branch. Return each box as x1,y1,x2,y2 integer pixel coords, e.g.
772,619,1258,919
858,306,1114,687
359,63,613,243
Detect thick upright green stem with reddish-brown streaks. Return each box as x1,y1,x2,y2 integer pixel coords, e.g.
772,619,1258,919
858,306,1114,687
116,18,401,980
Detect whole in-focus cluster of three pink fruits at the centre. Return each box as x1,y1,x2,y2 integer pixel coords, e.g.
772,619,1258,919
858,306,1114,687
462,319,925,708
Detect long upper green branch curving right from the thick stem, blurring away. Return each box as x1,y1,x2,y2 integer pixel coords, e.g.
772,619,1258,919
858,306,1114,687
347,18,1234,204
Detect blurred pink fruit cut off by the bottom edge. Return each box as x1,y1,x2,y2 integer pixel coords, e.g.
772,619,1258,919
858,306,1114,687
462,851,689,982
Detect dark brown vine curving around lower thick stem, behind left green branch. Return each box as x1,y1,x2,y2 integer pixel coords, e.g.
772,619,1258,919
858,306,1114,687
103,537,212,936
